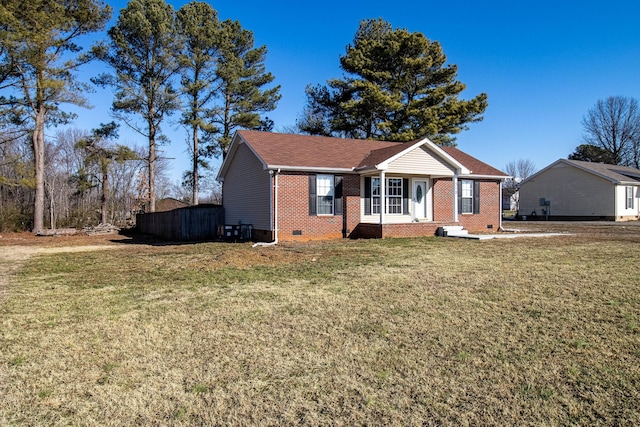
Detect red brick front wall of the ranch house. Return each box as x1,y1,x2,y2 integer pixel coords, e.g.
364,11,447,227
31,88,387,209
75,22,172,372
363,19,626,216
272,172,501,241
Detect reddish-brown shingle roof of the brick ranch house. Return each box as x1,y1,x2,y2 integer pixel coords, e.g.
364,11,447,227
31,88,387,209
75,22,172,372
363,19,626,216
232,130,507,177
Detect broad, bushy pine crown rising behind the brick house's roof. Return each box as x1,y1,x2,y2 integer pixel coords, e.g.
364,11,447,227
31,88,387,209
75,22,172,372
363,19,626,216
298,19,487,145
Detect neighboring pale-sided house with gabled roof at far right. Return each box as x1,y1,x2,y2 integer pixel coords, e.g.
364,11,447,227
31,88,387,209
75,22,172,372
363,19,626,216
519,159,640,221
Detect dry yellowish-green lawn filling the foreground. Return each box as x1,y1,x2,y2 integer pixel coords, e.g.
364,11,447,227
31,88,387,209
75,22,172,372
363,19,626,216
0,226,640,425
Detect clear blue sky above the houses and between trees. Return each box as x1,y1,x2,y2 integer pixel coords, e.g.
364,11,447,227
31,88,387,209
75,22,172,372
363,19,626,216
74,0,640,181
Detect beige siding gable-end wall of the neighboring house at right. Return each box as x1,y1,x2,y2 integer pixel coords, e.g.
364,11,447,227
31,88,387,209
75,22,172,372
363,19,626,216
520,163,615,217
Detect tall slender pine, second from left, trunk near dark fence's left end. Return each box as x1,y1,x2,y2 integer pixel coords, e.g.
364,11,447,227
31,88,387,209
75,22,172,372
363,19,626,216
95,0,183,212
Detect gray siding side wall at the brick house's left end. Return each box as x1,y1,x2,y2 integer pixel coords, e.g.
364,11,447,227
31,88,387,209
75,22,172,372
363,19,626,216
222,144,272,230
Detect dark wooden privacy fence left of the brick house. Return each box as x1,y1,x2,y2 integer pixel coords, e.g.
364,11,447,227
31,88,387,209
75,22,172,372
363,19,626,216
136,205,224,242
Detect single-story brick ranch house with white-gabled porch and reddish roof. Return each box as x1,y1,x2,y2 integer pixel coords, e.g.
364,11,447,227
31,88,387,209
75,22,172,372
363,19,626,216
217,130,507,242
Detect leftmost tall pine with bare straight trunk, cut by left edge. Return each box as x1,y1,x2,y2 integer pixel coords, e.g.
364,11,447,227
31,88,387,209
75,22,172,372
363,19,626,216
0,0,111,233
